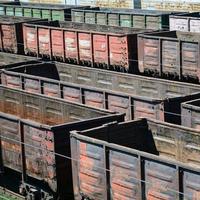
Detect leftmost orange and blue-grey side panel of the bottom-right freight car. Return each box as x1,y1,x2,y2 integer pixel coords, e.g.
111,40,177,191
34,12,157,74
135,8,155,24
77,141,106,200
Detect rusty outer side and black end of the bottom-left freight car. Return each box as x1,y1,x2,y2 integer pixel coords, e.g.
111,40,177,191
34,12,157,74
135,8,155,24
0,112,124,199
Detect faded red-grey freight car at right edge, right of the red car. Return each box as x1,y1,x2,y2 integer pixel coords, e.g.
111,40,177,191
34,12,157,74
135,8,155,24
138,31,200,82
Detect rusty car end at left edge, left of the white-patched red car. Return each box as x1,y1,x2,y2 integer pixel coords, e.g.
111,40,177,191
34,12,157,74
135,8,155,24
0,16,46,54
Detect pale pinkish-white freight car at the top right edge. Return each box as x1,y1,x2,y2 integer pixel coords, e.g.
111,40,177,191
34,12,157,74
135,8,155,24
169,12,200,33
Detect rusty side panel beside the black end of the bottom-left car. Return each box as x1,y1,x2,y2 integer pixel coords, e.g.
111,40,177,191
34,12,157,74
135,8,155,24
24,125,57,191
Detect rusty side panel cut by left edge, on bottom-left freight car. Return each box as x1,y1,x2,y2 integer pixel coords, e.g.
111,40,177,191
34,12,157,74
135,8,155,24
0,117,22,172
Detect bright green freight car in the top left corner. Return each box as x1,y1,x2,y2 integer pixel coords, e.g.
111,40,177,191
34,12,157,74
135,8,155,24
0,1,90,21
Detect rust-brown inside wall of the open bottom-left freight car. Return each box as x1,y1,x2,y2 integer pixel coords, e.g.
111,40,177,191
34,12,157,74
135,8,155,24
0,86,112,125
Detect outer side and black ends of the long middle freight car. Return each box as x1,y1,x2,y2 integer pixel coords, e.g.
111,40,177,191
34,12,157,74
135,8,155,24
1,63,199,124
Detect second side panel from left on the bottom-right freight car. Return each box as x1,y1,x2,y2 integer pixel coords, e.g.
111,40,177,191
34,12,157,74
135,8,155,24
109,149,141,200
